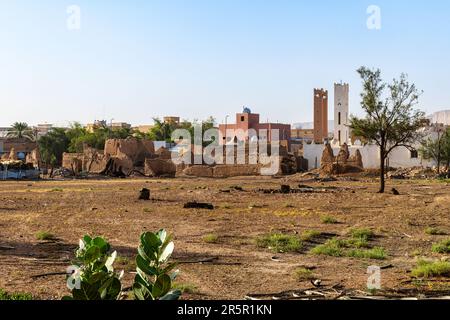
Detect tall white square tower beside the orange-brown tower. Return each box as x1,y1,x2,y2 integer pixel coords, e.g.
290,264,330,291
333,82,350,146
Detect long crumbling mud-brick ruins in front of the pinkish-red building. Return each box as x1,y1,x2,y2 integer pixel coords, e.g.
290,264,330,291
62,138,304,178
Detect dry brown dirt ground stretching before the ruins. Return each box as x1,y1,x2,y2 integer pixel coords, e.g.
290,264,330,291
0,176,450,299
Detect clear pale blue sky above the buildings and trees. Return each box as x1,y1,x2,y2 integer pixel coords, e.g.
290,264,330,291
0,0,450,126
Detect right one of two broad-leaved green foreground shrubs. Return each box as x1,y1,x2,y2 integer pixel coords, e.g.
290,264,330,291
133,230,181,300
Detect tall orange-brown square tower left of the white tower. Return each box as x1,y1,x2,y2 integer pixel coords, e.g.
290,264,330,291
314,89,328,143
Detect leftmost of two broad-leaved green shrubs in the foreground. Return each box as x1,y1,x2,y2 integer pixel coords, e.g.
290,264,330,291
63,236,122,300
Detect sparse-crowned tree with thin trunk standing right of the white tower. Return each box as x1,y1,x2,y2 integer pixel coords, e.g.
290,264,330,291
350,67,425,193
